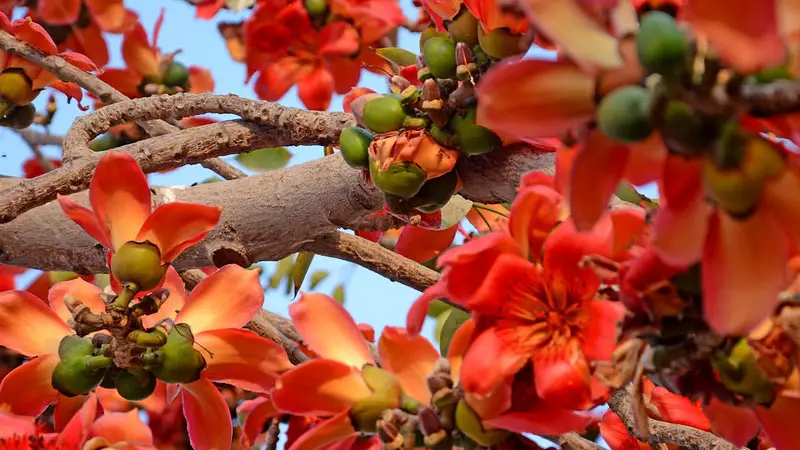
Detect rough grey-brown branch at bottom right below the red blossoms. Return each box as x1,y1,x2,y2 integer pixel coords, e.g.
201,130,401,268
608,388,747,450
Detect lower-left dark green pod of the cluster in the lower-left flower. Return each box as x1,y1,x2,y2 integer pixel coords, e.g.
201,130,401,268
50,356,111,397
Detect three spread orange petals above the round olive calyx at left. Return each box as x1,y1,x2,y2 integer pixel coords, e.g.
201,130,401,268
58,151,222,284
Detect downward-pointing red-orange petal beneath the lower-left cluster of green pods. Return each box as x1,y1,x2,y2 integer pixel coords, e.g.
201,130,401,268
181,378,233,450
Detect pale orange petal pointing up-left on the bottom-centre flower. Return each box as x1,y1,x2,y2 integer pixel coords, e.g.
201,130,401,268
289,293,375,369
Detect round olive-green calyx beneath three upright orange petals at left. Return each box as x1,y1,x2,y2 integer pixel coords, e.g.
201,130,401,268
111,241,167,291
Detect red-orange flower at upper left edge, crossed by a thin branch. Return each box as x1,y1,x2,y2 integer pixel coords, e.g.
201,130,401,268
0,14,97,105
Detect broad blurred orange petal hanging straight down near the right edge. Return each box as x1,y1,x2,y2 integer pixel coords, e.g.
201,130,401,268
701,208,789,335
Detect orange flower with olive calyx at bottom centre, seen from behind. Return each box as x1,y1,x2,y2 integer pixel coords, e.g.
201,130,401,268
270,293,439,450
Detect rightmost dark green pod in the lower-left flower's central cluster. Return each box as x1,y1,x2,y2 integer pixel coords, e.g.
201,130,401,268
145,323,206,383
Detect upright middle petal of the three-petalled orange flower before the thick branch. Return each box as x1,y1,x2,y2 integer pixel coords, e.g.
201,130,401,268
89,151,150,250
